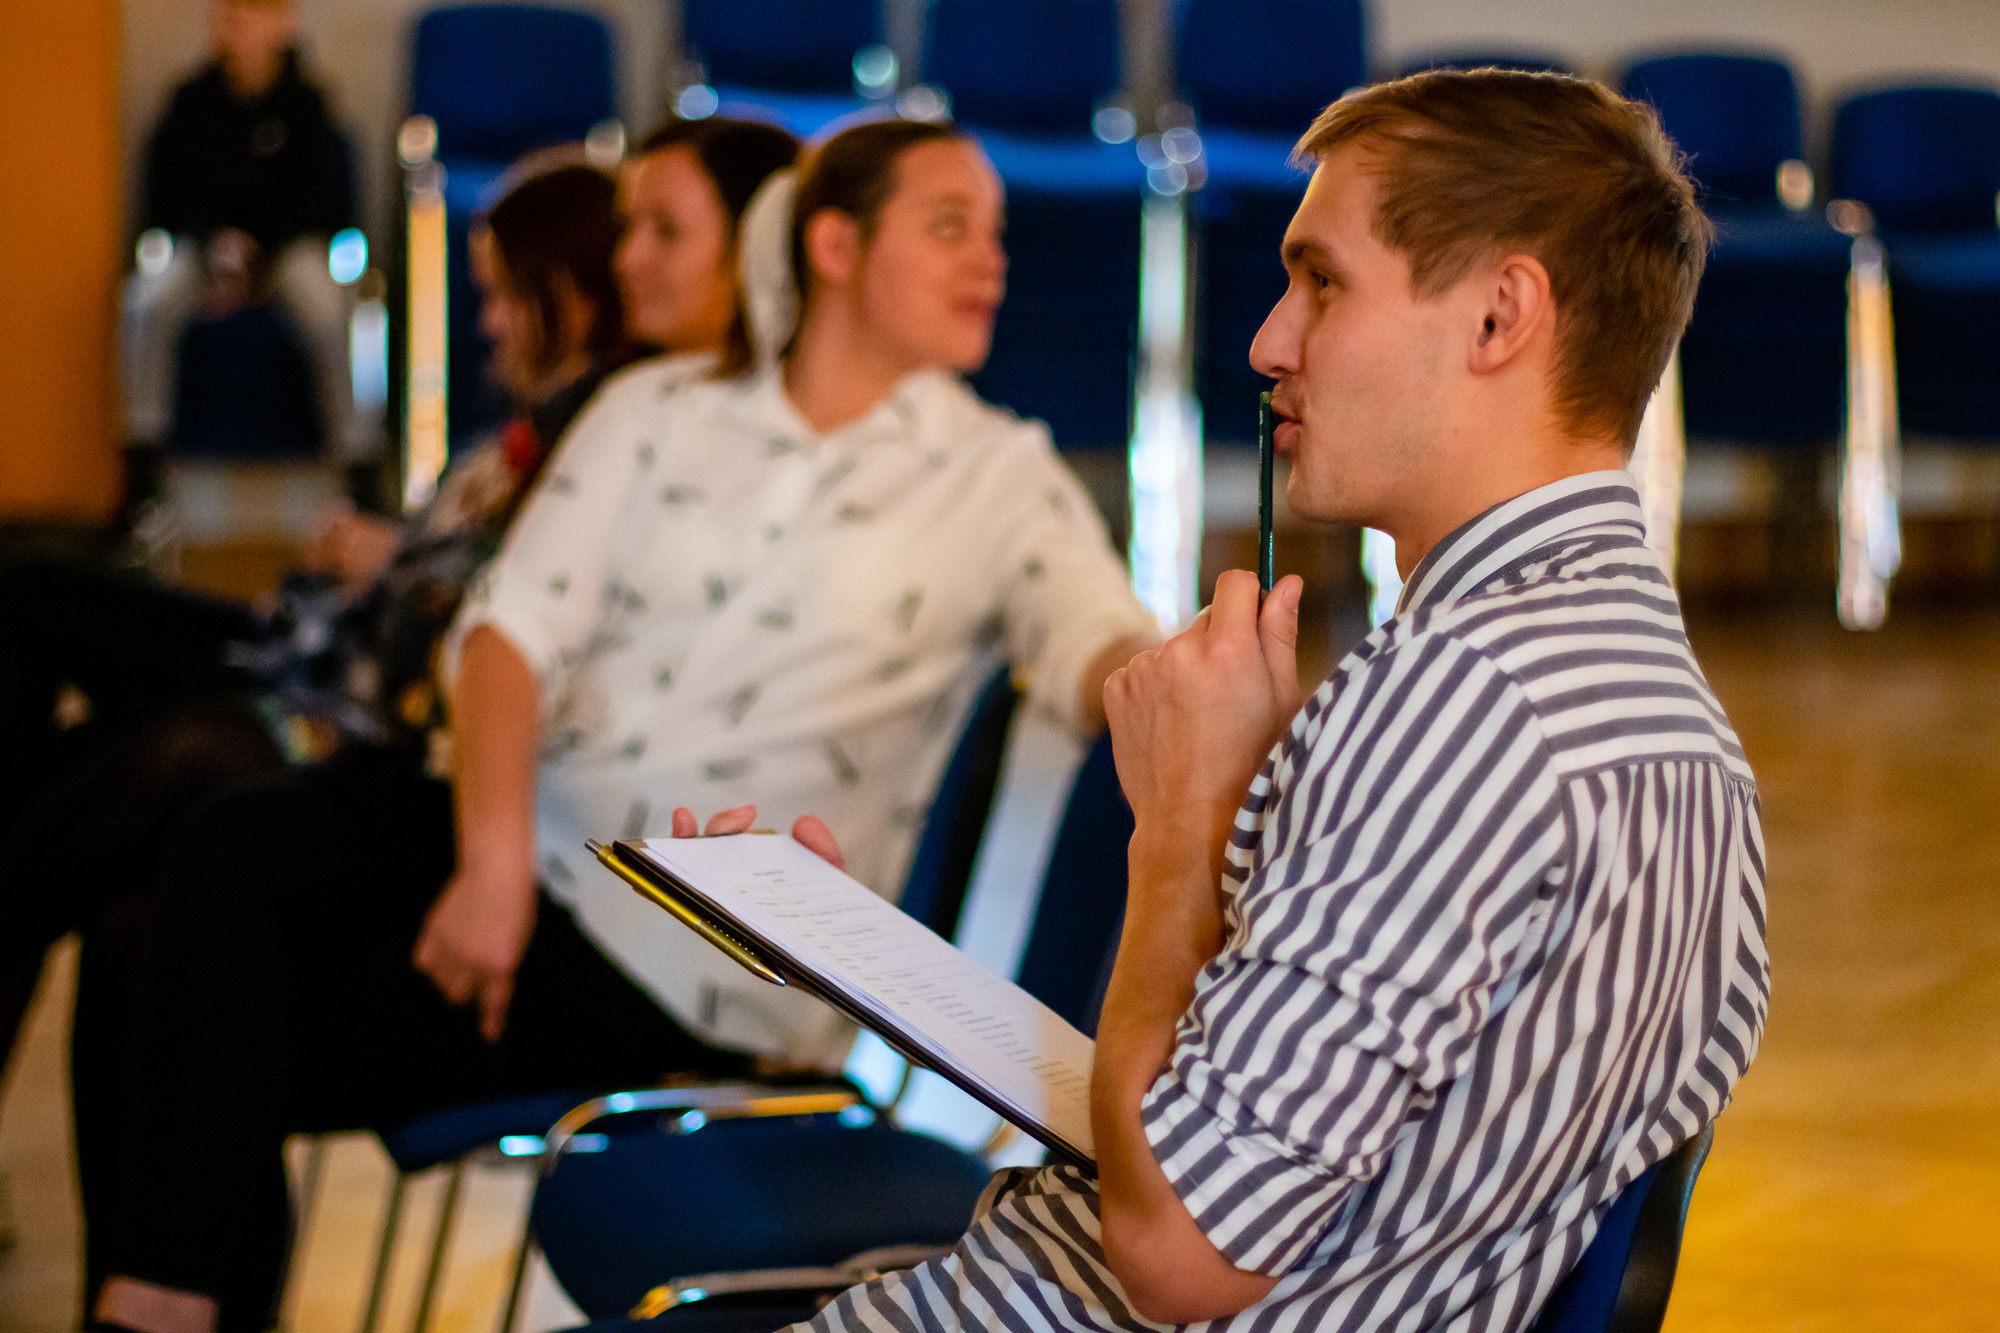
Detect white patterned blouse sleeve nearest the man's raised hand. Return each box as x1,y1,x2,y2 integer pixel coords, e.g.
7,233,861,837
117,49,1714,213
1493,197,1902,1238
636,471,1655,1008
984,424,1160,727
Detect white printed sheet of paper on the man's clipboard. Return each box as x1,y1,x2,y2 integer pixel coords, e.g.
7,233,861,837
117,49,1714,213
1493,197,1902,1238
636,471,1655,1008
638,833,1096,1155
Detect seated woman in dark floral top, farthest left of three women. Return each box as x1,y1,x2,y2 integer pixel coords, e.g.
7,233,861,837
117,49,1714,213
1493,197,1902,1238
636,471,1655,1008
0,164,626,1088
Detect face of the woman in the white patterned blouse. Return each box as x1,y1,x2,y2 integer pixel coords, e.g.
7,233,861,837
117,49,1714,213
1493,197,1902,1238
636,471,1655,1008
856,138,1006,370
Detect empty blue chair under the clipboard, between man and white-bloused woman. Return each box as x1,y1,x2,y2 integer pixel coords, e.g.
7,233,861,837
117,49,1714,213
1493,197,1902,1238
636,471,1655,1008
530,737,1132,1333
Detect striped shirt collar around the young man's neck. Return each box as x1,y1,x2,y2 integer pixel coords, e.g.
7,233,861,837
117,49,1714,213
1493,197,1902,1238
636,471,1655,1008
1396,468,1646,614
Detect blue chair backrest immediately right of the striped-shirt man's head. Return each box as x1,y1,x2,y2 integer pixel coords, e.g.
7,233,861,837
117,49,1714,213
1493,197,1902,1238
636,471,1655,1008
1622,52,1800,206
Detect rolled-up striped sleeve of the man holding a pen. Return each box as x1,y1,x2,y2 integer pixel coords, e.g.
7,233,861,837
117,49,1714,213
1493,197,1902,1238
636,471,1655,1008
1140,644,1568,1275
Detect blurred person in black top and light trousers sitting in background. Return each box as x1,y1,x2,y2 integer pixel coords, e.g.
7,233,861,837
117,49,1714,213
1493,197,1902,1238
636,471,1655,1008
120,0,376,474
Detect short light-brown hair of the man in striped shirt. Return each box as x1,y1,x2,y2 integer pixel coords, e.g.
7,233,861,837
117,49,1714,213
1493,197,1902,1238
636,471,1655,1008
1298,70,1714,446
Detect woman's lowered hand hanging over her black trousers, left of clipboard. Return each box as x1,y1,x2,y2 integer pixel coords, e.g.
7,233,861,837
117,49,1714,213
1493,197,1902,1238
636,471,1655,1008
412,867,536,1041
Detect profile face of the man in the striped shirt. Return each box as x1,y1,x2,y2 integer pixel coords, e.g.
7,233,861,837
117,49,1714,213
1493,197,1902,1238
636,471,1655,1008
1250,146,1464,526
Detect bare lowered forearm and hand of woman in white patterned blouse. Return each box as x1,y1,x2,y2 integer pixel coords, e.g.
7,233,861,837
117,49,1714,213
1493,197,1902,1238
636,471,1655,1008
414,624,540,1041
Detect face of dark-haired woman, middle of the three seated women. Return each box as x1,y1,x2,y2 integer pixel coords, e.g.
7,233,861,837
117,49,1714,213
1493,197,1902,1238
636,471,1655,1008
612,148,736,352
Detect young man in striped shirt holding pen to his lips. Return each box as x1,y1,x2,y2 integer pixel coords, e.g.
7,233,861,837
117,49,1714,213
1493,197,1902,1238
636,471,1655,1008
796,72,1768,1333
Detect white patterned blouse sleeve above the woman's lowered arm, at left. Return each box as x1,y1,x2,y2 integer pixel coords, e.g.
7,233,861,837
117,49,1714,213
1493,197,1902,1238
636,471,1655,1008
440,366,646,701
